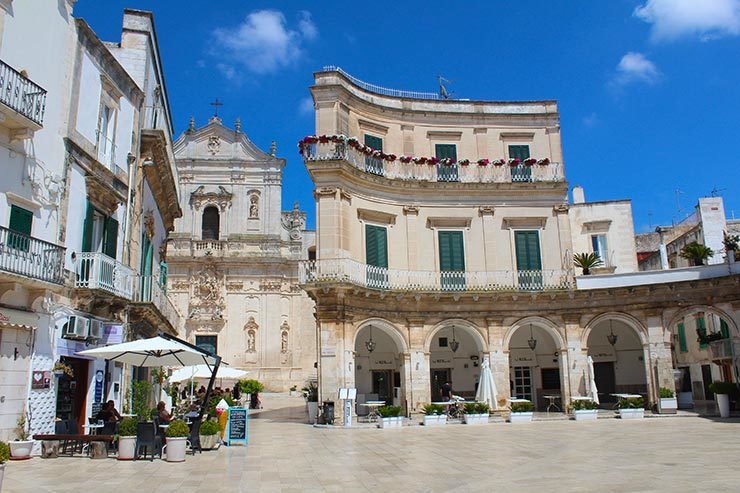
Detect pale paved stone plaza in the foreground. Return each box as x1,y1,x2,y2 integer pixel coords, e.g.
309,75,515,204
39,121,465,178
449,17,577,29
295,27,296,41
3,395,740,493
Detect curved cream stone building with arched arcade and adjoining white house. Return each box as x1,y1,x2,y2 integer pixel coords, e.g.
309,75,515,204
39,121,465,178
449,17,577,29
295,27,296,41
299,67,740,418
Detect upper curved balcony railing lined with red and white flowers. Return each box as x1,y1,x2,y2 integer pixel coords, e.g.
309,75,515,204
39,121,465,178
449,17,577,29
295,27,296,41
300,142,564,183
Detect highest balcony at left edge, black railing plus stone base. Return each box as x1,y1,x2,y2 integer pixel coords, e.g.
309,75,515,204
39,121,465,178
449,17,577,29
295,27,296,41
0,60,46,132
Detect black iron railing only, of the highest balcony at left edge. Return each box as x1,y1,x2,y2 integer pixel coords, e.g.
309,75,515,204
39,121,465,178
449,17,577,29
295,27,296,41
0,60,46,125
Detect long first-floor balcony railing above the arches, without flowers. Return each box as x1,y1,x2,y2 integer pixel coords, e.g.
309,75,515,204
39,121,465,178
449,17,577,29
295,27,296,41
299,259,573,292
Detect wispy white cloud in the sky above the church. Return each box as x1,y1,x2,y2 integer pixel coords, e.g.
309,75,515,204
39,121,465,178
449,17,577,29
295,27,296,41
214,10,318,74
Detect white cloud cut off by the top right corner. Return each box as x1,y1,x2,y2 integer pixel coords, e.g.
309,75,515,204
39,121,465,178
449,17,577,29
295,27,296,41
634,0,740,42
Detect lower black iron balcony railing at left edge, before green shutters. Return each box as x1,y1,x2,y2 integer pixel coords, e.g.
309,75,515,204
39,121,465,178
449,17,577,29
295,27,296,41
0,226,64,284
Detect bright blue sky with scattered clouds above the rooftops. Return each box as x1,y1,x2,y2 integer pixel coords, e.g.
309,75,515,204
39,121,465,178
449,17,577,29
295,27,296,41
75,0,740,232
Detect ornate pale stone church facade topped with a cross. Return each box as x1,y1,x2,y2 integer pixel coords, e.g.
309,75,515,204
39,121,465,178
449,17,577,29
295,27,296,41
168,116,316,390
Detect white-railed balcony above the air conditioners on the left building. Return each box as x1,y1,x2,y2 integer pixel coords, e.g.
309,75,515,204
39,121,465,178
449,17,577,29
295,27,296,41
75,252,136,300
